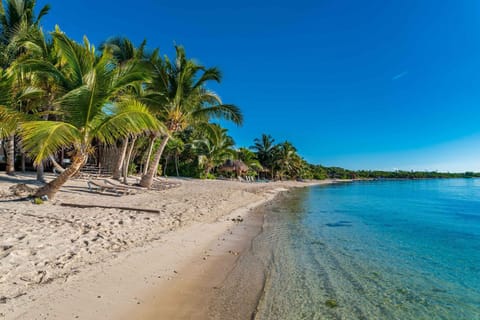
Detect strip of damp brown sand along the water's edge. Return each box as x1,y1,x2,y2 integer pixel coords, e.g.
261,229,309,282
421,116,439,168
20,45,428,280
123,190,274,320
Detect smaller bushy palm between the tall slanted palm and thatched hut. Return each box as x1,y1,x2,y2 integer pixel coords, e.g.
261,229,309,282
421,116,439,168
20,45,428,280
194,124,236,175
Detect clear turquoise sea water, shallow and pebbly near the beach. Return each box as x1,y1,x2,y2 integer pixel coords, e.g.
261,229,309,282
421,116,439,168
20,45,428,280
252,179,480,320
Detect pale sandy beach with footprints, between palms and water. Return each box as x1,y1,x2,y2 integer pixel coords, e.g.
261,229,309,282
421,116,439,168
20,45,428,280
0,175,329,319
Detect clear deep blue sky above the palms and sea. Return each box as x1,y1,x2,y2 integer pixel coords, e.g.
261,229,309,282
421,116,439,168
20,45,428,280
38,0,480,171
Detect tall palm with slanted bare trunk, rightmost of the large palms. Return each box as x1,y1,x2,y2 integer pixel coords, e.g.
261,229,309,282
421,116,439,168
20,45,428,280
140,46,243,188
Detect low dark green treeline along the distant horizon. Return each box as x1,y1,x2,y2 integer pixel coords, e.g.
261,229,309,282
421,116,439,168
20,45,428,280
310,165,480,179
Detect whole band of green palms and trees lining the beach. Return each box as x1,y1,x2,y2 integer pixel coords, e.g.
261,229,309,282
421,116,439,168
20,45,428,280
0,0,479,198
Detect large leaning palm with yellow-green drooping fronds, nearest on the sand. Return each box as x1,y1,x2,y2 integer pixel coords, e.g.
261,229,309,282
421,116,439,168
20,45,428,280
20,28,160,198
